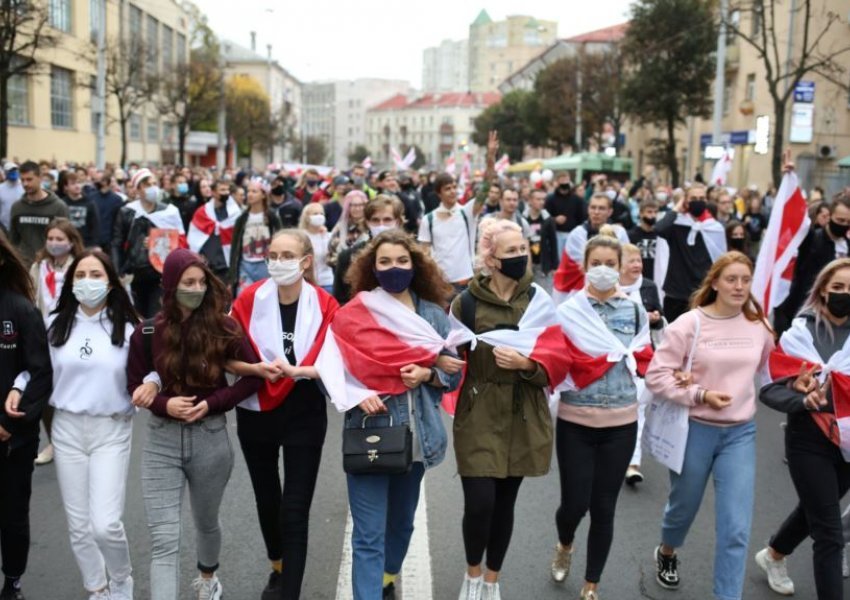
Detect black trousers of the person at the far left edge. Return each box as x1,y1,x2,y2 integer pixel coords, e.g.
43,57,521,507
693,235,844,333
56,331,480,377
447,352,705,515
0,438,38,578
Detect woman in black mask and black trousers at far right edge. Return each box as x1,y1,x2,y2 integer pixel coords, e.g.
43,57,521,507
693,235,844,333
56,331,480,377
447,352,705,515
755,258,850,600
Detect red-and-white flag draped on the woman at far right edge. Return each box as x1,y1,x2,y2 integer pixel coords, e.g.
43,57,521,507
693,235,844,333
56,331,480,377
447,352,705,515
768,317,850,461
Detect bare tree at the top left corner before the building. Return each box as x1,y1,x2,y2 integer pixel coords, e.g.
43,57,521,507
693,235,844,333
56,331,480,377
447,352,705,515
0,0,58,156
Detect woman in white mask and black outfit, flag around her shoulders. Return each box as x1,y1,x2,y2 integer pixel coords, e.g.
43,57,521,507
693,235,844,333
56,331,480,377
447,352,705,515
229,231,339,599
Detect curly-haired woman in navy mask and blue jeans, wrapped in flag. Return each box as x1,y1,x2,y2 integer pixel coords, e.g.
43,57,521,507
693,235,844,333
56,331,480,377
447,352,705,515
320,229,463,600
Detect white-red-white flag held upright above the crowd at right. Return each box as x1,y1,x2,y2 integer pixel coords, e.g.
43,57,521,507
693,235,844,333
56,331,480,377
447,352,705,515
753,171,811,316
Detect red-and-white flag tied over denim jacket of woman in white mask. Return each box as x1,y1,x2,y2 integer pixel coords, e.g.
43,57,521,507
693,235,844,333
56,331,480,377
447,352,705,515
558,293,652,391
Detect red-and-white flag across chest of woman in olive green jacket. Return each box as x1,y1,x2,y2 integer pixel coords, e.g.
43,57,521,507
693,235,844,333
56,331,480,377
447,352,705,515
443,284,571,414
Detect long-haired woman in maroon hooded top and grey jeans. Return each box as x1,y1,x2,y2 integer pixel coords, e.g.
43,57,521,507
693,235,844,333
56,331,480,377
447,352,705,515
127,249,263,600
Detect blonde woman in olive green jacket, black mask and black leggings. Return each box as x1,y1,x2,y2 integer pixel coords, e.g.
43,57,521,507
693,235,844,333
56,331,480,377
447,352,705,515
452,219,552,600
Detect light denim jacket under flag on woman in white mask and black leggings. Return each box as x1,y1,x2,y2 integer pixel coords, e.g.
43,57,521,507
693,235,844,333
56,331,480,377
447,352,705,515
561,296,647,408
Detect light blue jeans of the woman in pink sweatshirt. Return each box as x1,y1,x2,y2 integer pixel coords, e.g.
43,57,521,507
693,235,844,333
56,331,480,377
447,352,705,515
661,419,756,600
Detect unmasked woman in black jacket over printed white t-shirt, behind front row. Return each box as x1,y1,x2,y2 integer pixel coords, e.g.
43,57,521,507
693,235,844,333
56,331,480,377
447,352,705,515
227,178,281,298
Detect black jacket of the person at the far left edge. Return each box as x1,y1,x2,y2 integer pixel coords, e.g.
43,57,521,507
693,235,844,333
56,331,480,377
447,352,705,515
0,289,53,449
